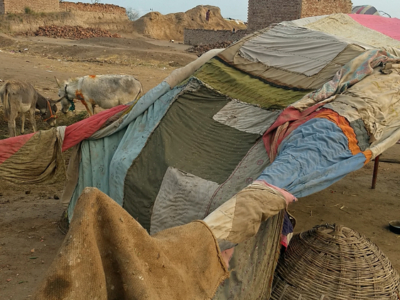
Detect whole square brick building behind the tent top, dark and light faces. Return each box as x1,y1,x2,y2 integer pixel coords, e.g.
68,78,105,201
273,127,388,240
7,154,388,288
247,0,352,32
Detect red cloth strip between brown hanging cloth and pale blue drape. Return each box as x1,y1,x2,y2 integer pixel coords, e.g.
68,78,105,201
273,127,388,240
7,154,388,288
62,105,129,151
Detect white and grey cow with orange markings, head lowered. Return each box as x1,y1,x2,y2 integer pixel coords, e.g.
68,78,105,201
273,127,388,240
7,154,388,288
56,75,143,116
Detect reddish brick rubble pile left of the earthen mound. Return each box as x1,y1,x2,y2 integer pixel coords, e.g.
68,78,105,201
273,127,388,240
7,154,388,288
25,25,121,40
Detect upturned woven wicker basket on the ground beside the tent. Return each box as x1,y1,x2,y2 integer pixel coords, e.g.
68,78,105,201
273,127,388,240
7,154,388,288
271,225,400,300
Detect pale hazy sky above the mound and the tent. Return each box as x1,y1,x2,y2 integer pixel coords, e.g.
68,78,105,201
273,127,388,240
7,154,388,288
73,0,400,21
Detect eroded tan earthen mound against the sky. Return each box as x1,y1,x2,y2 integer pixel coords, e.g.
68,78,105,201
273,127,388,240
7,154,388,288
134,5,246,41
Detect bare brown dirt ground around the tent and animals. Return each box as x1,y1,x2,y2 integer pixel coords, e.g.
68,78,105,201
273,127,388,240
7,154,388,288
0,32,400,299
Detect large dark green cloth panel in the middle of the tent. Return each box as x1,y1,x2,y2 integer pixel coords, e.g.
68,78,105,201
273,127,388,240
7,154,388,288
123,79,259,230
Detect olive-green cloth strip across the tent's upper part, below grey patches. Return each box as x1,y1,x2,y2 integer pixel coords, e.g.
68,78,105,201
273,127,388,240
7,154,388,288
194,58,309,109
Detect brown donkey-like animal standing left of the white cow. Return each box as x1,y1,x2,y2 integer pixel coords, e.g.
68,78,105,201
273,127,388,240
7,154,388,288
0,80,57,137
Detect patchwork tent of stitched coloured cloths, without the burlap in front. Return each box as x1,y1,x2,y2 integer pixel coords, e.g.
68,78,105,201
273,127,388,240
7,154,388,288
0,14,400,299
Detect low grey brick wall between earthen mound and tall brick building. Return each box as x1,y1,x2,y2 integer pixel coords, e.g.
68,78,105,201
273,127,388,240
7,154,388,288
184,29,247,46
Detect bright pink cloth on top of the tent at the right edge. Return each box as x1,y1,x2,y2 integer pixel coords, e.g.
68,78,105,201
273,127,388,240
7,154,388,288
349,14,400,41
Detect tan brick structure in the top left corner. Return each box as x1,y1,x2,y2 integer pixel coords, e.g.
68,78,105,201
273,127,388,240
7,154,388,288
0,0,59,14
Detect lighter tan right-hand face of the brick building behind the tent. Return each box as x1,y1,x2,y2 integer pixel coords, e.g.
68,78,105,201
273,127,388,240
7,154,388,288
301,0,353,18
